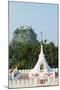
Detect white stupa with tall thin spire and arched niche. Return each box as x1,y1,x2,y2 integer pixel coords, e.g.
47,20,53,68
30,33,53,75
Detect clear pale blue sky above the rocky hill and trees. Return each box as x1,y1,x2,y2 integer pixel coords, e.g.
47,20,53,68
9,1,59,45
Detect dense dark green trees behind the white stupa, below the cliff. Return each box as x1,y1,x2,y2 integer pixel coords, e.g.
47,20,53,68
9,25,58,69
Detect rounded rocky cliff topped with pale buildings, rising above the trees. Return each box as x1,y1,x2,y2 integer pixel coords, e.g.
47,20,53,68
13,26,37,43
